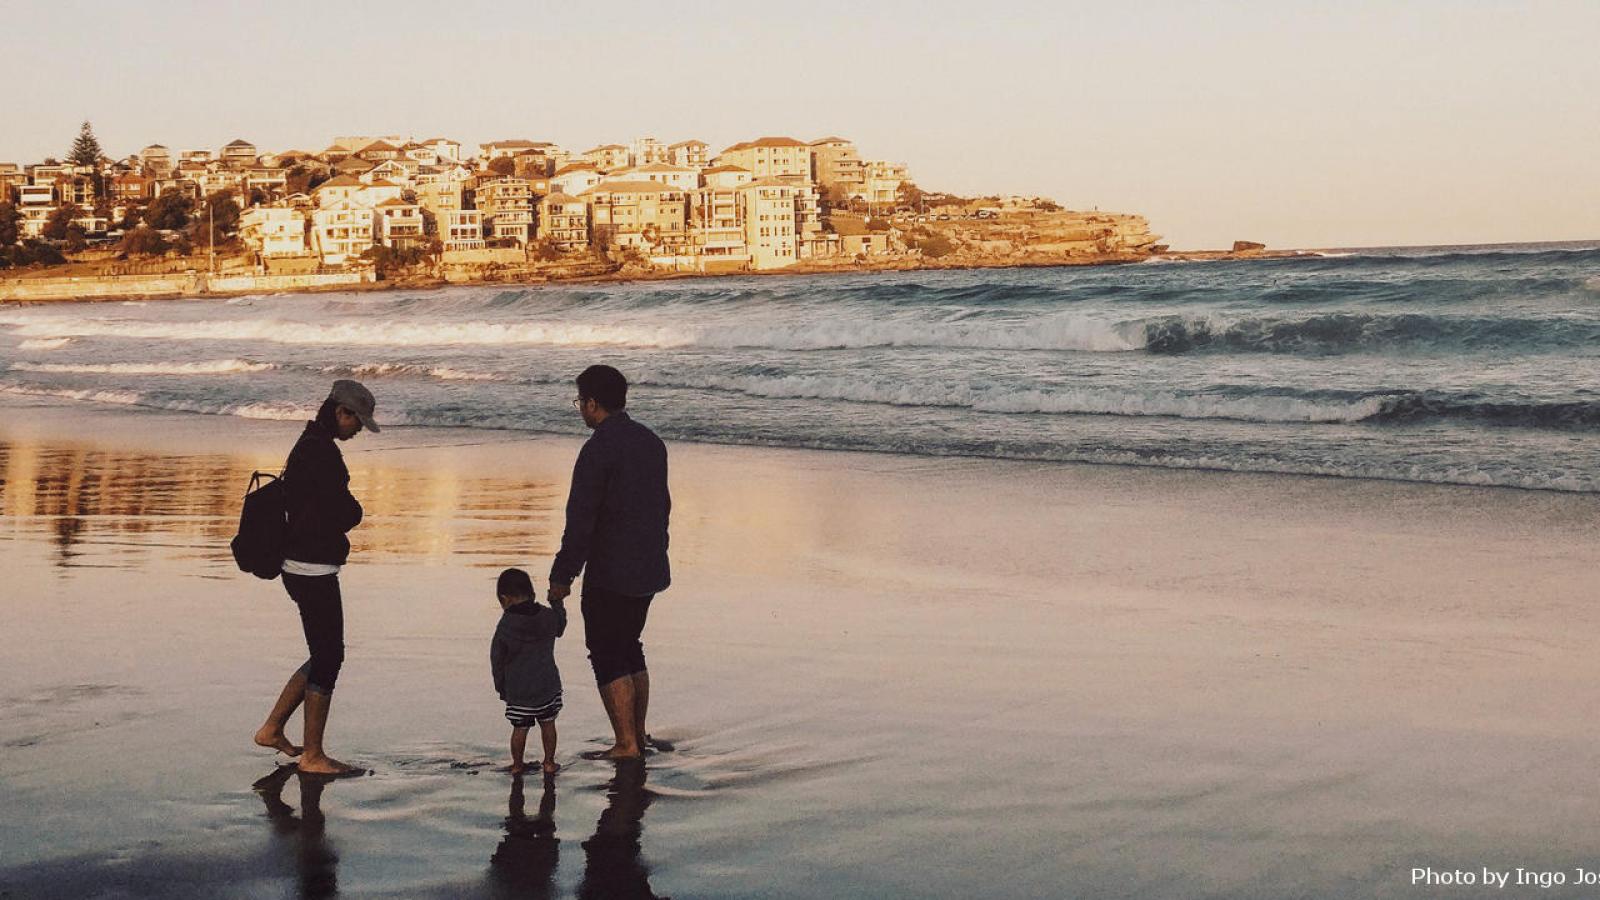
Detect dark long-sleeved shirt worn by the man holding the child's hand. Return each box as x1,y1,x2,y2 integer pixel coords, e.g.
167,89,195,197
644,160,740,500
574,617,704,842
550,410,672,597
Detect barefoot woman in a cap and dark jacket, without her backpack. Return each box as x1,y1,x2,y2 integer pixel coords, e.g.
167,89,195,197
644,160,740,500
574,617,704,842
256,380,378,775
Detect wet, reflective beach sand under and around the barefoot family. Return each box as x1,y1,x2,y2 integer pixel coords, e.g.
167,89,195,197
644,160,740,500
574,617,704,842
0,404,1600,898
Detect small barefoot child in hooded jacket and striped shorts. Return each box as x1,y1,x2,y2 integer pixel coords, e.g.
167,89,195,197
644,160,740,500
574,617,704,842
490,569,566,775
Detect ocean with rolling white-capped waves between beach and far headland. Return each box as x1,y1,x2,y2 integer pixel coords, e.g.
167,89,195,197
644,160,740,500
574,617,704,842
0,243,1600,492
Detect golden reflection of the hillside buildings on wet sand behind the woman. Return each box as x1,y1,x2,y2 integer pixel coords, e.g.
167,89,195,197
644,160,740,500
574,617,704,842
0,439,562,567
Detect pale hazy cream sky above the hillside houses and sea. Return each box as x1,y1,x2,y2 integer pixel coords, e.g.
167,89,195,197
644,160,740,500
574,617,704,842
0,0,1600,247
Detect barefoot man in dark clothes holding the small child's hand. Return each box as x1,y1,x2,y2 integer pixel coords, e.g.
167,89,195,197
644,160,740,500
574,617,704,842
550,365,672,759
